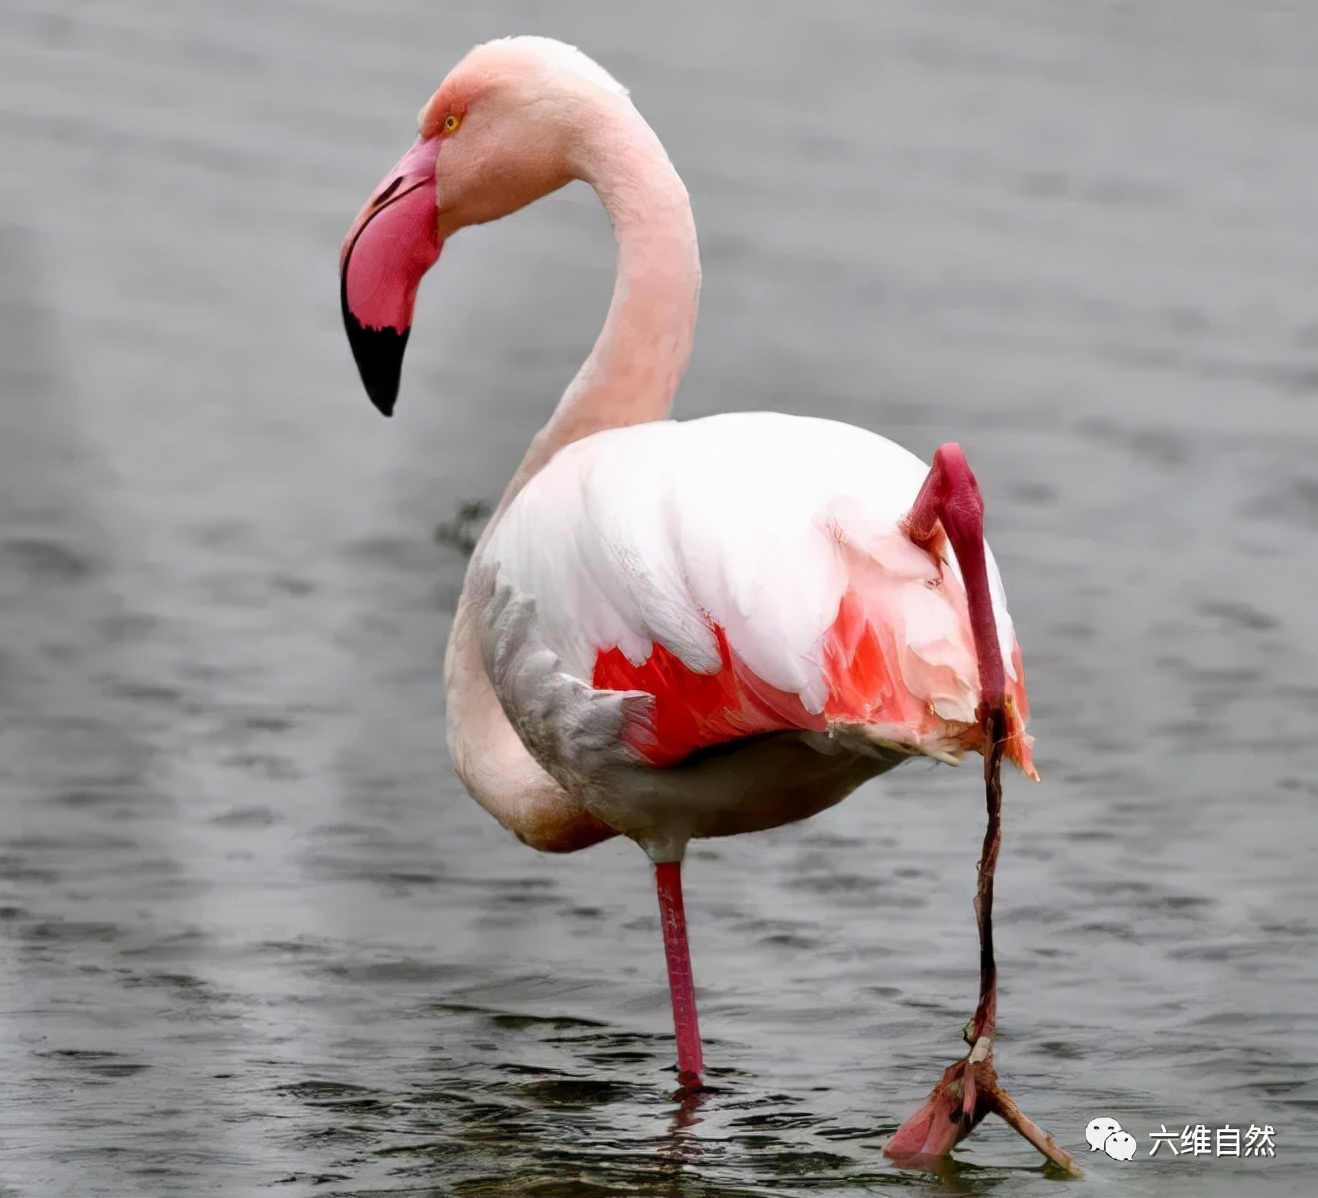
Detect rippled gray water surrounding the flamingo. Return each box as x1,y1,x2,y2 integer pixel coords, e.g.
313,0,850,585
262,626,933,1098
0,0,1318,1198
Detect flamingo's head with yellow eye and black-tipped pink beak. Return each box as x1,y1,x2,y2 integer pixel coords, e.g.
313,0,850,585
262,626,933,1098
339,37,630,416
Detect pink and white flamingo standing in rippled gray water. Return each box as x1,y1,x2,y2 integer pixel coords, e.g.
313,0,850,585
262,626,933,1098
340,37,1070,1170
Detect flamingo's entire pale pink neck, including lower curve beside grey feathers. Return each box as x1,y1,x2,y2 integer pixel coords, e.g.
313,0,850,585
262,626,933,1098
444,101,700,850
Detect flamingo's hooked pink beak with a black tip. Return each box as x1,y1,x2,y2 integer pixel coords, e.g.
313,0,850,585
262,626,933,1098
339,137,442,416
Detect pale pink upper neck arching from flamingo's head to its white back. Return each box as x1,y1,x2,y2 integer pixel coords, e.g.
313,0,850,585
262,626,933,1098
503,101,700,503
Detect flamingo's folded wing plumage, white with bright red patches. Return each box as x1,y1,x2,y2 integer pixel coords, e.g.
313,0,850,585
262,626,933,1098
476,413,1032,772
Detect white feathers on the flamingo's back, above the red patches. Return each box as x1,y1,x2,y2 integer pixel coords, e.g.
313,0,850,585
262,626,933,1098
478,413,1015,720
